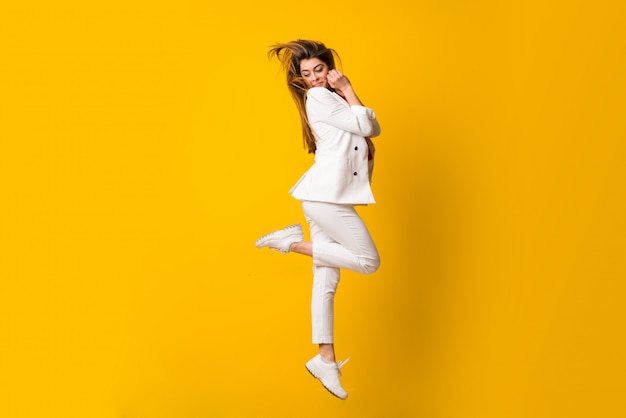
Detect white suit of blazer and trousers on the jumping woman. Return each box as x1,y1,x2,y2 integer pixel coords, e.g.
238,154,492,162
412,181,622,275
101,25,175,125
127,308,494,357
289,87,380,344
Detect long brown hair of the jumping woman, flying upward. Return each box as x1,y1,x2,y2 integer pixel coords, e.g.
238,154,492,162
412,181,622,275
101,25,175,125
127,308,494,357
268,39,341,153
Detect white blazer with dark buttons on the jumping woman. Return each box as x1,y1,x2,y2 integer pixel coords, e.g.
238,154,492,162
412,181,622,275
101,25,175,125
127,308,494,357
289,87,380,205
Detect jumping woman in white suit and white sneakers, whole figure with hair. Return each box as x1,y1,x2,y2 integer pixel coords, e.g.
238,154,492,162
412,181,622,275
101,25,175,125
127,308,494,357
256,40,380,399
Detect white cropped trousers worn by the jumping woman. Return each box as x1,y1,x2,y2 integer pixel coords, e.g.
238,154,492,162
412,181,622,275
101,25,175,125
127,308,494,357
302,201,380,344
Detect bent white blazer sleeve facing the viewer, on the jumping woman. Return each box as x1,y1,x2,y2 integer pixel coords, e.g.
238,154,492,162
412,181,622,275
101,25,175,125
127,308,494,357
306,87,380,138
